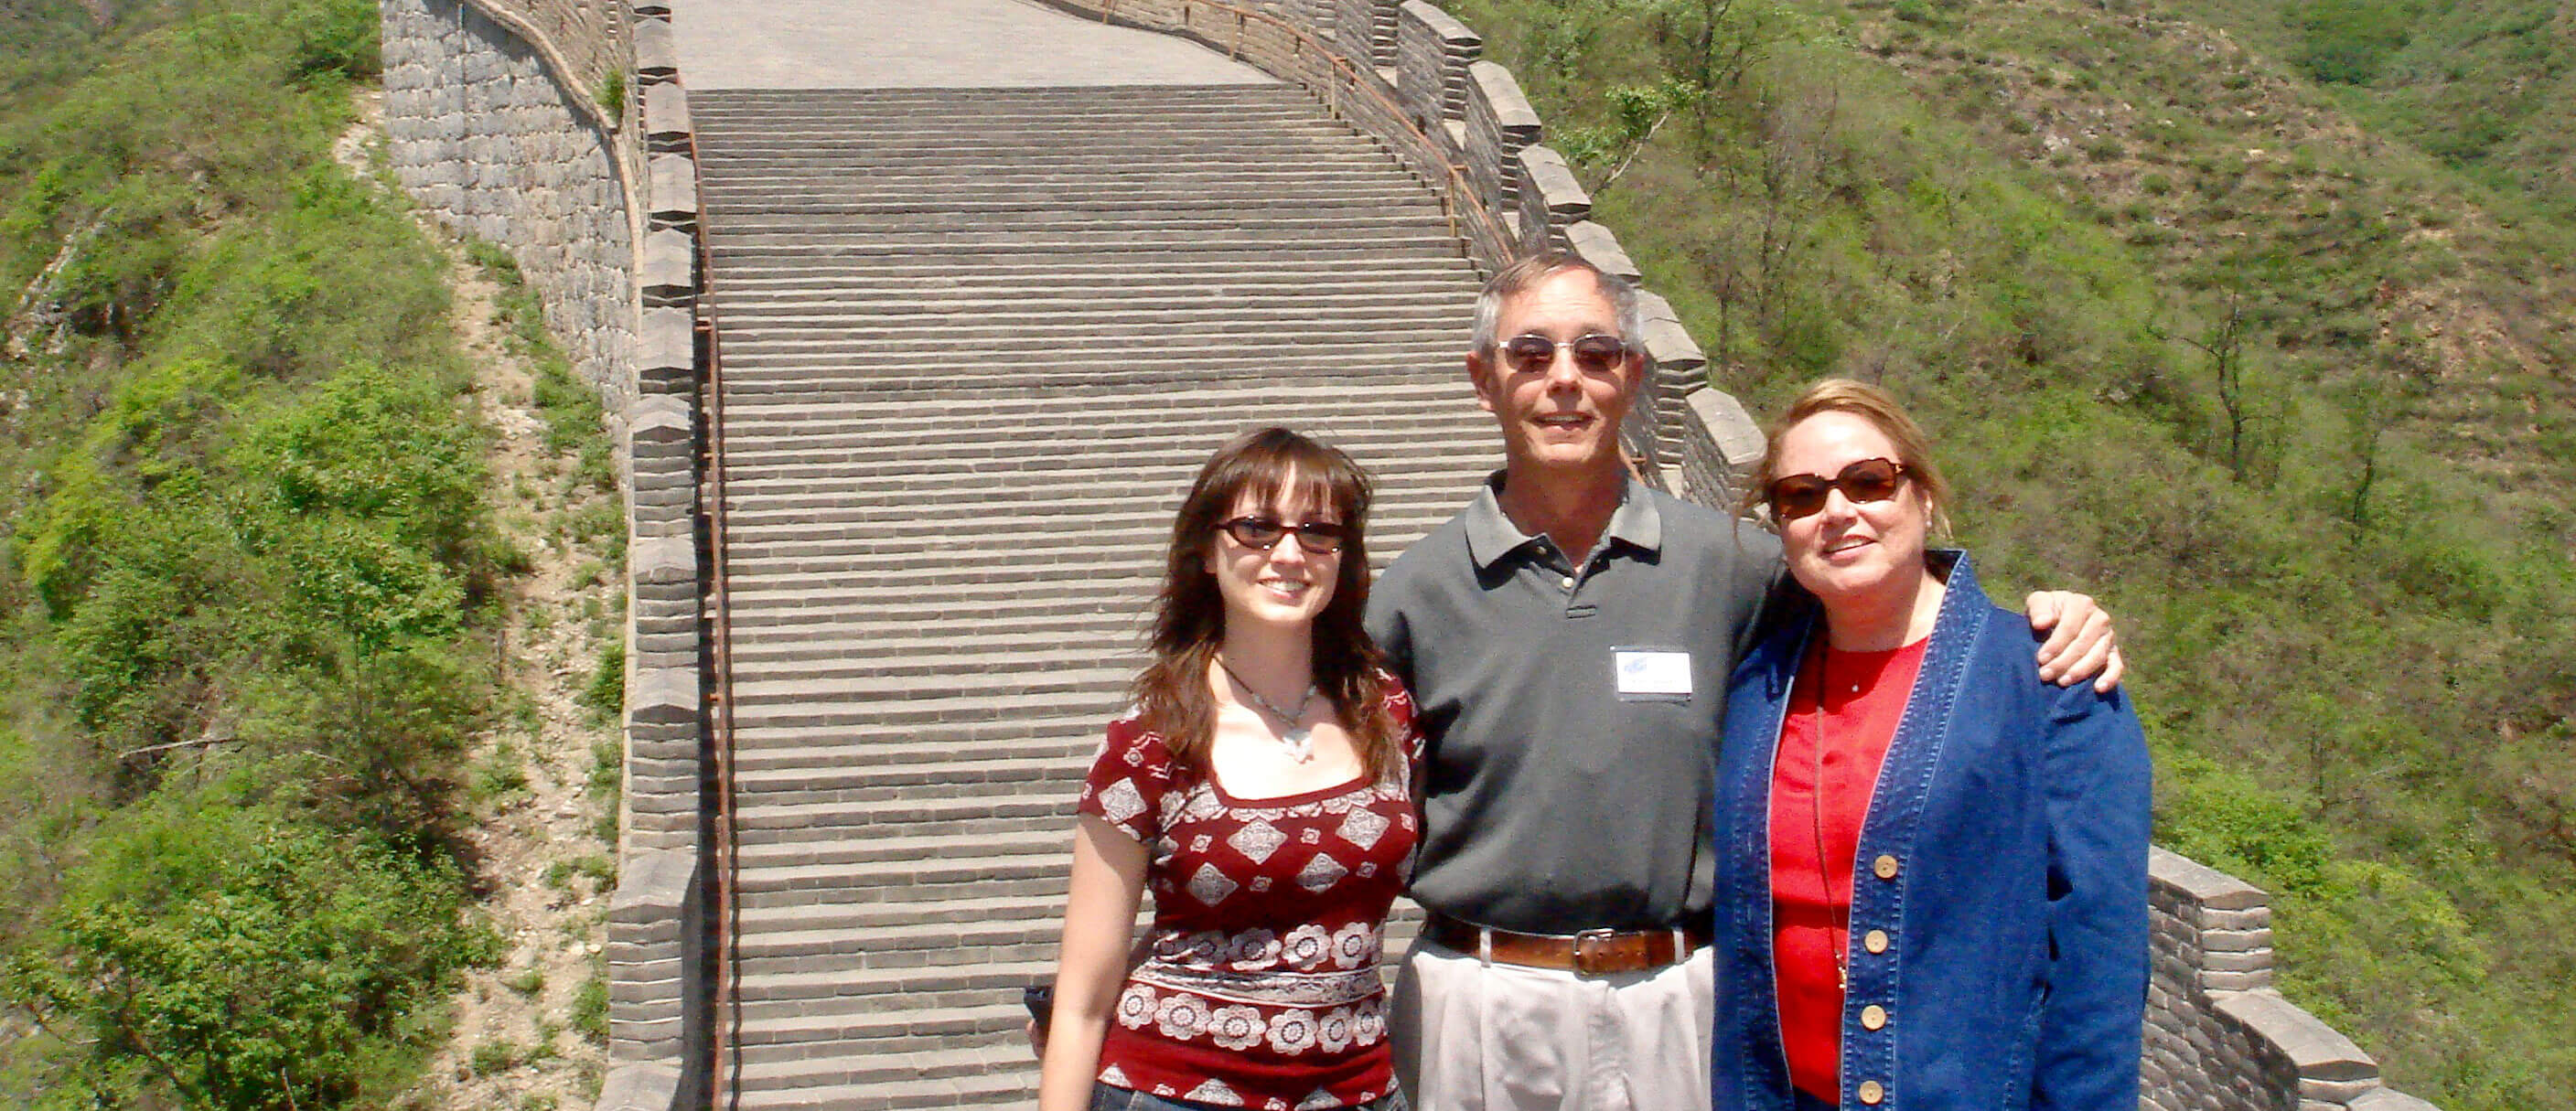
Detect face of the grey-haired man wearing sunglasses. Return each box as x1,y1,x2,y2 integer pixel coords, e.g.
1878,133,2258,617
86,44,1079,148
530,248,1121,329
1465,271,1644,475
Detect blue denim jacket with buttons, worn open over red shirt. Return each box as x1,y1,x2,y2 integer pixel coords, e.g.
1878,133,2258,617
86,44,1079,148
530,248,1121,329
1711,551,2149,1111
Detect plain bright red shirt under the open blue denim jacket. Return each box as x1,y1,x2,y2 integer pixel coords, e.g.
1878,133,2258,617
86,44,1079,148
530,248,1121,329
1770,636,1929,1104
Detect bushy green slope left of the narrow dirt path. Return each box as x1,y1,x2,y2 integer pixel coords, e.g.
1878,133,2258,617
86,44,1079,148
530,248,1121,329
0,0,518,1108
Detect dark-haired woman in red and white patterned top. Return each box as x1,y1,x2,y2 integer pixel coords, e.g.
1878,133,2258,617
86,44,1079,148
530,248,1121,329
1038,428,1420,1111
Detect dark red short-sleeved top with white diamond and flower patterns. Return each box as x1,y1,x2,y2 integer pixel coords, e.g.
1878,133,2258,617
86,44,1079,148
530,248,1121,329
1079,678,1422,1111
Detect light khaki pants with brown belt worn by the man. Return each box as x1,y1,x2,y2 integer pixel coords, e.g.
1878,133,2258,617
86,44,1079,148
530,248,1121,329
1389,941,1715,1111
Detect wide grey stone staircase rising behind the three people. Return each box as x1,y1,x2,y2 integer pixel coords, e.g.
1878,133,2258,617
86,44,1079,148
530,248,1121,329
691,85,1499,1108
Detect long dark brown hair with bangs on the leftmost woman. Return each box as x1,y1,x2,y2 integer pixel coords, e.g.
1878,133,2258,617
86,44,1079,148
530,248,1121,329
1133,428,1404,781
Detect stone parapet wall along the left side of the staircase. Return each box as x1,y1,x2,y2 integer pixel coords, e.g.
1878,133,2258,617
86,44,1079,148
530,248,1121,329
381,0,714,1111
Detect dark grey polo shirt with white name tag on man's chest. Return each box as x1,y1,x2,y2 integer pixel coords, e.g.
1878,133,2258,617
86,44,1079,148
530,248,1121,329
1368,475,1783,933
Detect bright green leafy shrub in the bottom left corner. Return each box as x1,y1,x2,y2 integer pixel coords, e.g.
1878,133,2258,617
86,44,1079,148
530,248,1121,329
0,794,492,1108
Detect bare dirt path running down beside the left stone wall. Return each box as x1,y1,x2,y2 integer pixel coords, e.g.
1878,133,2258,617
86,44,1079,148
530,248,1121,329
332,91,626,1111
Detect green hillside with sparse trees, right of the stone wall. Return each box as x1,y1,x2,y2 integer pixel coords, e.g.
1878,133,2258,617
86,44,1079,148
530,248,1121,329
1445,0,2576,1111
